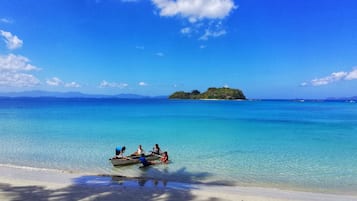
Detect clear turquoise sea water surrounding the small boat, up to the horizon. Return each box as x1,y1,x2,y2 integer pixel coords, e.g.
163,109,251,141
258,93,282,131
0,98,357,193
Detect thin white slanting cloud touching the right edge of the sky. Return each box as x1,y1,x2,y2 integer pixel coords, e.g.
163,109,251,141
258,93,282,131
300,67,357,87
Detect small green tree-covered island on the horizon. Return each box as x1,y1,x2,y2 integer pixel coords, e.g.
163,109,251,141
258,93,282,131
169,87,246,100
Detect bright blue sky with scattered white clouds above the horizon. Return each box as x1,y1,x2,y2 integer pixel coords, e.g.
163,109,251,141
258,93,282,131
0,0,357,98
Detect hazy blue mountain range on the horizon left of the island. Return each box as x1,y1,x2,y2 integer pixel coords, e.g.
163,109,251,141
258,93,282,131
0,91,167,99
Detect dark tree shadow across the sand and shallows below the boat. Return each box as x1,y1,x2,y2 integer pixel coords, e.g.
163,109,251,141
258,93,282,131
0,168,233,201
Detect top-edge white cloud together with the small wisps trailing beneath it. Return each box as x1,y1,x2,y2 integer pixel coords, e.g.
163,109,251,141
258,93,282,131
152,0,238,40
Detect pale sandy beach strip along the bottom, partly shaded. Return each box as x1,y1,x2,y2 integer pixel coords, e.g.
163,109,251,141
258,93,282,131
0,166,357,201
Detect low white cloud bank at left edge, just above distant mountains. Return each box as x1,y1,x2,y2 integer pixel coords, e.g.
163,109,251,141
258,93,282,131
0,54,40,87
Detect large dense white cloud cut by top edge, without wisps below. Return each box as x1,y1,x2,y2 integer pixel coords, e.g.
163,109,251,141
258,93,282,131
152,0,237,23
